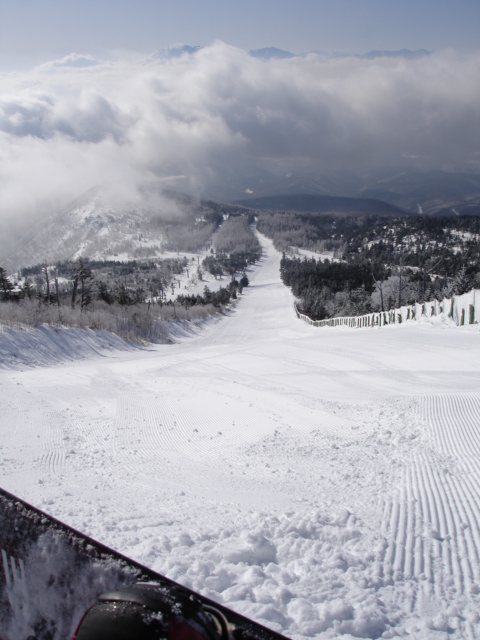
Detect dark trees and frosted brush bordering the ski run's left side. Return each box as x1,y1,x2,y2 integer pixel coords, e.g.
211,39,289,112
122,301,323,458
0,258,232,342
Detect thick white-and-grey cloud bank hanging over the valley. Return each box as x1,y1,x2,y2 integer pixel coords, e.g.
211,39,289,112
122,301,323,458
0,42,480,255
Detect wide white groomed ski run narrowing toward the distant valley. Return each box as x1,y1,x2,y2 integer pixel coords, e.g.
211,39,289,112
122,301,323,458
0,232,480,639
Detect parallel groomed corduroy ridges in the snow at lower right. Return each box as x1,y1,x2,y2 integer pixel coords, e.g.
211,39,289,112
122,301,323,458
378,395,480,639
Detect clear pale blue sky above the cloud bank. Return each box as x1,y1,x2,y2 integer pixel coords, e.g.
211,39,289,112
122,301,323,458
0,0,480,69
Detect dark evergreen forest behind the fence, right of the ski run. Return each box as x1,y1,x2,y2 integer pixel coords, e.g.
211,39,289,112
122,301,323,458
258,212,480,320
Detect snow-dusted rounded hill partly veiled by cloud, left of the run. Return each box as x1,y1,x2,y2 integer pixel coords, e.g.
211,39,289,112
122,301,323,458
2,187,238,273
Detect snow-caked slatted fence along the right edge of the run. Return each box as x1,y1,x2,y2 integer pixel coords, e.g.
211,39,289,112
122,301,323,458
293,289,480,329
